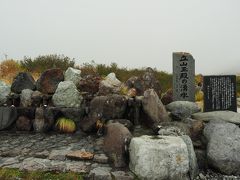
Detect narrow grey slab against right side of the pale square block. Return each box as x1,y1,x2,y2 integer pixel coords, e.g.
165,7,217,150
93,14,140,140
181,135,199,180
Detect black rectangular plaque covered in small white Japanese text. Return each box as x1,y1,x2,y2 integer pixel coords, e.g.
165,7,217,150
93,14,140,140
203,75,237,112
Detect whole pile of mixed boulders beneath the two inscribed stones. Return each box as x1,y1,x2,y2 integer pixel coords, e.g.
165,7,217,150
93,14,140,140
0,68,240,180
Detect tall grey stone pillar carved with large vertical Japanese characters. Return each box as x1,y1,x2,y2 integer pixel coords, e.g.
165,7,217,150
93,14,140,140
173,52,195,102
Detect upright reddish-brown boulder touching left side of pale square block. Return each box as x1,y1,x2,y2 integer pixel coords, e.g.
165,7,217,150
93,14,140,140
104,123,132,168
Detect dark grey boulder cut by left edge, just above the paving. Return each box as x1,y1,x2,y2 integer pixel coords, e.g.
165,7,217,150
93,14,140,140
0,107,17,130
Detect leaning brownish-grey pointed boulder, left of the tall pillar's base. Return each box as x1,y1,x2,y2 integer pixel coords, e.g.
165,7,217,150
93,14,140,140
142,89,169,129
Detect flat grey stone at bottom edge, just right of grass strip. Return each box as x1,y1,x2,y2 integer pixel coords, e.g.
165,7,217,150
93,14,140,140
89,167,112,180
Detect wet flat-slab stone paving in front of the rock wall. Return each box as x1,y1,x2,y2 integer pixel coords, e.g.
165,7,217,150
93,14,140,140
0,132,133,179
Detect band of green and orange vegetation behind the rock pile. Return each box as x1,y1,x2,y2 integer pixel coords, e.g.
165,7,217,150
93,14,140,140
0,54,240,97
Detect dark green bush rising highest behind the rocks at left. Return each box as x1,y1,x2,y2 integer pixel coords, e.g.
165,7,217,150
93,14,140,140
20,54,75,73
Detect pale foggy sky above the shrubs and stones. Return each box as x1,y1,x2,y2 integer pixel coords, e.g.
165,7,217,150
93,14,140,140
0,0,240,74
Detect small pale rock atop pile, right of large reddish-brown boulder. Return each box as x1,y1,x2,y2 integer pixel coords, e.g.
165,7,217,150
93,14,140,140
64,67,82,86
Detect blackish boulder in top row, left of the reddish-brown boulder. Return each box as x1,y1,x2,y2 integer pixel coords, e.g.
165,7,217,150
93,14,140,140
11,72,36,94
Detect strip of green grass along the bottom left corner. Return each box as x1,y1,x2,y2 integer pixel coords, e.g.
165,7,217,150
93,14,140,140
0,168,83,180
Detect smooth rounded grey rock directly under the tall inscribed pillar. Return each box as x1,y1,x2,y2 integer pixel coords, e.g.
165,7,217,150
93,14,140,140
166,101,201,120
